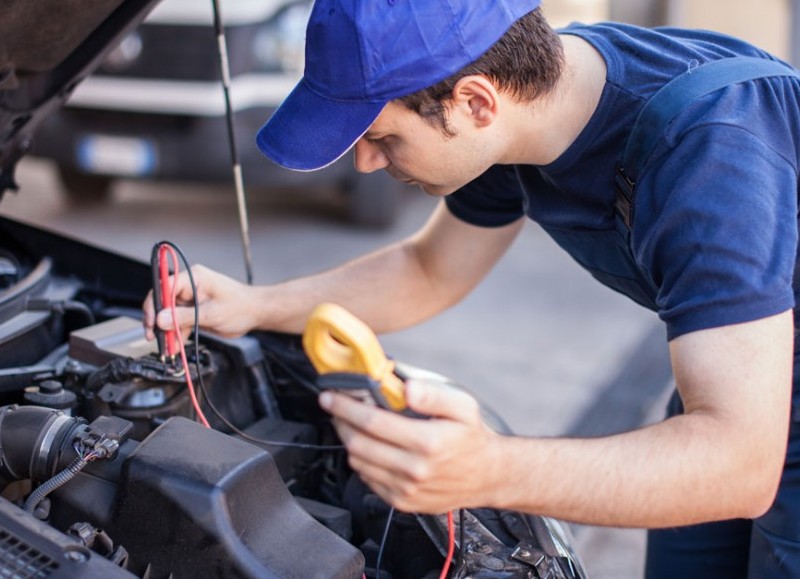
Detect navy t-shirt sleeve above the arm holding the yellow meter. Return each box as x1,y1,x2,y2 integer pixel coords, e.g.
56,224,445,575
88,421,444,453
633,125,797,339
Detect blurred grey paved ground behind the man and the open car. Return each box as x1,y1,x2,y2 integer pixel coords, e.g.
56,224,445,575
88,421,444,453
2,160,668,579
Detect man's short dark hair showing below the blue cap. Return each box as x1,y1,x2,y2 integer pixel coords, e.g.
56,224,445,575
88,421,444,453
397,8,564,135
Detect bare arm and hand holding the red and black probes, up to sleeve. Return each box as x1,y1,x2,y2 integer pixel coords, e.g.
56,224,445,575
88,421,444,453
144,203,524,335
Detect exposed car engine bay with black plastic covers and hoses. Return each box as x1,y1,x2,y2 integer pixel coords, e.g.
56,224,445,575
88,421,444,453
0,219,584,579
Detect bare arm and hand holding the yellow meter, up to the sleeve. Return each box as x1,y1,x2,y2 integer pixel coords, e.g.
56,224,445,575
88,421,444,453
321,312,793,527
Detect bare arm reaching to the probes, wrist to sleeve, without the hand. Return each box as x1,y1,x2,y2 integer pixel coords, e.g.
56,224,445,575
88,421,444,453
250,203,524,333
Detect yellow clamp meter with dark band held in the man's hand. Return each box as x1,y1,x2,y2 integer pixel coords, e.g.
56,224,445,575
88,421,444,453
303,303,406,412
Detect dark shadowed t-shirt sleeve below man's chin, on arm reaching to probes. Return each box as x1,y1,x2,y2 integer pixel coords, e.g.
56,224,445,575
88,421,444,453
445,165,525,227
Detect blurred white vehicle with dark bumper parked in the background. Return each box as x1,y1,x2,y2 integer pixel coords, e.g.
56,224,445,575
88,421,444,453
30,0,405,227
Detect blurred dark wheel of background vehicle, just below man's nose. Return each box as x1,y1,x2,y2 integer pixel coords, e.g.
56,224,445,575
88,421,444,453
343,171,404,229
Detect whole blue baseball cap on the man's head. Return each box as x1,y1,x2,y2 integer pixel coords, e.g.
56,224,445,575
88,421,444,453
256,0,540,171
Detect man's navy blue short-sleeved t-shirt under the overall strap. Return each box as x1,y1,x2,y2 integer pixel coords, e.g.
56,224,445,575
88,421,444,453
446,23,800,339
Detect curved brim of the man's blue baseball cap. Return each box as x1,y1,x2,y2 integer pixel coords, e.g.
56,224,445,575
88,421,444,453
256,80,386,171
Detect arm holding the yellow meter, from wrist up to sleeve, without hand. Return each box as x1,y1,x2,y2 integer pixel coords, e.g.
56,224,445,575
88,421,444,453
476,312,793,527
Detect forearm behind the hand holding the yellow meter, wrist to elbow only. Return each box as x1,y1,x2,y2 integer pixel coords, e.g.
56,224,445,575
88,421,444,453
486,415,784,528
